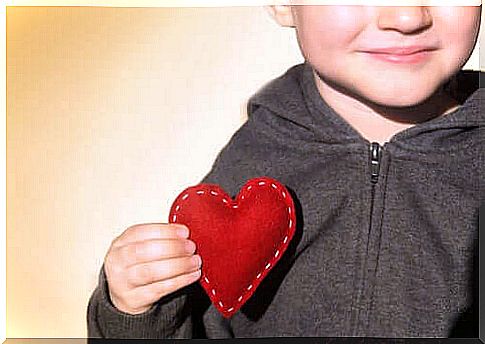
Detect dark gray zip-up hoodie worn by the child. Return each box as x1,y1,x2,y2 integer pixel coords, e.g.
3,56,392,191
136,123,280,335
87,63,484,338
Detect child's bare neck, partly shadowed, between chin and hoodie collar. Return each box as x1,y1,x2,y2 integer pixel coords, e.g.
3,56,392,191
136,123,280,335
314,71,459,144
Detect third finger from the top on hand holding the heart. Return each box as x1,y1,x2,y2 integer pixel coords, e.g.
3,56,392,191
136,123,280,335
127,255,202,288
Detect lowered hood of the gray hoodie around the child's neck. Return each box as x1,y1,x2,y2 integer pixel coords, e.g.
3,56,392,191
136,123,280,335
248,63,485,150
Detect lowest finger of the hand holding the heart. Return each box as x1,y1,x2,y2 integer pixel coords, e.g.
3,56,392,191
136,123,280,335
126,270,201,309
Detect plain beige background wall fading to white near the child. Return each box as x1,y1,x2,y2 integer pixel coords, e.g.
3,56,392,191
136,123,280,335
7,7,483,338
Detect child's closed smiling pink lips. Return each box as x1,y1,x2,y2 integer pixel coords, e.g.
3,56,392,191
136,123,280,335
360,46,437,64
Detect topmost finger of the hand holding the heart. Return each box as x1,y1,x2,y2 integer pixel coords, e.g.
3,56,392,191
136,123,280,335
112,223,189,248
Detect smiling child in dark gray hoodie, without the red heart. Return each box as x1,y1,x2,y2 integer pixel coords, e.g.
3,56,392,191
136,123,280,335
87,5,483,338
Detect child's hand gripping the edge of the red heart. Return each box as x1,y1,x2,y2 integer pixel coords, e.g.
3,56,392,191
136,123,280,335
104,224,201,314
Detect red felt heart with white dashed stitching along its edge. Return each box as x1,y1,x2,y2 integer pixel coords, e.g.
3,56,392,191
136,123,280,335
169,177,296,318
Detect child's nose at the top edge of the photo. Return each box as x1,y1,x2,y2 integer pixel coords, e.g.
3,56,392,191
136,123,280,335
377,6,433,34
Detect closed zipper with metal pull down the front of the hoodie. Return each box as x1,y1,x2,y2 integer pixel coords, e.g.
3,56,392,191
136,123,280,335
352,142,383,336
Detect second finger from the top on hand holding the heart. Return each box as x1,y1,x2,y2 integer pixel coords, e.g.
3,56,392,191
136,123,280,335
113,239,196,268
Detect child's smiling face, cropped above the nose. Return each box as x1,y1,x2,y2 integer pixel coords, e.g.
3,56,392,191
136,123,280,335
272,6,481,106
